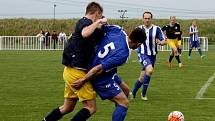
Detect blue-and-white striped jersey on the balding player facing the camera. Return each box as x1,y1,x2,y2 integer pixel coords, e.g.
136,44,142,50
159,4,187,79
137,25,165,55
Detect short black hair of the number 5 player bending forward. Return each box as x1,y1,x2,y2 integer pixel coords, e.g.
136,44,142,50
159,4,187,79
129,28,147,43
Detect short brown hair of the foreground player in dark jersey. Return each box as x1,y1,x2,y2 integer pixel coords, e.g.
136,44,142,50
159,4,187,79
85,2,103,14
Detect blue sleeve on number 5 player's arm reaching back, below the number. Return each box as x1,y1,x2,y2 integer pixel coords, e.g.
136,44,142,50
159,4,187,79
101,50,129,71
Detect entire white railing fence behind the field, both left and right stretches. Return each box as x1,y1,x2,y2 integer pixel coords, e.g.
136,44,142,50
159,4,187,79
0,36,208,51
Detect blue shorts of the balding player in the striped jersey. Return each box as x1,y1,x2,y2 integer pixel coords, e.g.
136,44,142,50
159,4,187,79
138,54,156,70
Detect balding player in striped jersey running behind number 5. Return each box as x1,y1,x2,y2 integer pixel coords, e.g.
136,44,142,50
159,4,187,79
130,12,166,100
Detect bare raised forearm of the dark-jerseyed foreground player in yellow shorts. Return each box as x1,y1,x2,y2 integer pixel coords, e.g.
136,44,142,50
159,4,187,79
81,18,107,38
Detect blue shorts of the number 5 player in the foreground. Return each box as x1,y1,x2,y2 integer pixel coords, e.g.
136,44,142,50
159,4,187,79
93,80,122,100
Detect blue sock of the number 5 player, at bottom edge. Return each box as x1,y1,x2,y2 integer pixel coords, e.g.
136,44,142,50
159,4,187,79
112,105,128,121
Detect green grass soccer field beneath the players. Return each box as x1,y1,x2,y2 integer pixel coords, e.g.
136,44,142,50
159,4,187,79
0,47,215,121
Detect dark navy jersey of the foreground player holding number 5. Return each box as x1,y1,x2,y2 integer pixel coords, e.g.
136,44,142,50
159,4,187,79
62,17,103,70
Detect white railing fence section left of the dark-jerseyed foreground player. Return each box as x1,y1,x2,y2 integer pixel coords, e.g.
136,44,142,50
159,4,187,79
0,36,67,50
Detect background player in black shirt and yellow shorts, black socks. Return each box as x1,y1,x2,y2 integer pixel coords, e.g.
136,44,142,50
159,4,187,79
162,16,182,68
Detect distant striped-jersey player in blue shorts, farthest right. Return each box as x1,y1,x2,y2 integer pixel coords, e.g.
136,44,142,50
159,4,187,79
188,21,205,59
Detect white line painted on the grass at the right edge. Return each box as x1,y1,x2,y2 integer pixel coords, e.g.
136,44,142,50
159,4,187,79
196,72,215,99
